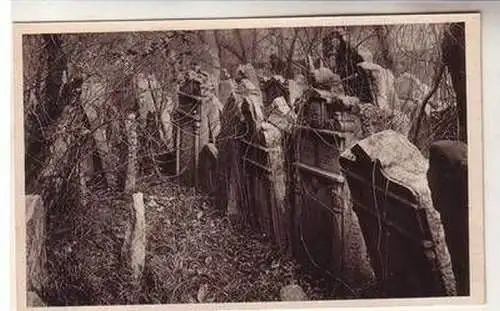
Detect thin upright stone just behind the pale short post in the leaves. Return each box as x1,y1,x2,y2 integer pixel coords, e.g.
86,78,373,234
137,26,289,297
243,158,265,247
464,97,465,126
125,114,139,192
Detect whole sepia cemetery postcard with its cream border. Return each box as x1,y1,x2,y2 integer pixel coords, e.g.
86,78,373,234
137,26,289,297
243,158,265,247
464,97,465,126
13,13,485,310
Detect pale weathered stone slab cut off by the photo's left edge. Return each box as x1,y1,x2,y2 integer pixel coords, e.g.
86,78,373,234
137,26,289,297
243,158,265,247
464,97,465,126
26,195,47,292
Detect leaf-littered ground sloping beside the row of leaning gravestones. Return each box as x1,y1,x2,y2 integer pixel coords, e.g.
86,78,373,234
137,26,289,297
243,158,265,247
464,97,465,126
44,180,332,305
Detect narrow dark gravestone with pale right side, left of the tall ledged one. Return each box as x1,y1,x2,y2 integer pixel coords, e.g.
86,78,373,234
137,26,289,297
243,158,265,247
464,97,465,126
238,86,290,251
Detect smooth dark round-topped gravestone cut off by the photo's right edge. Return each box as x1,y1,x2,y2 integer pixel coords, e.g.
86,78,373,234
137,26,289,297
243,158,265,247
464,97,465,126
427,141,470,296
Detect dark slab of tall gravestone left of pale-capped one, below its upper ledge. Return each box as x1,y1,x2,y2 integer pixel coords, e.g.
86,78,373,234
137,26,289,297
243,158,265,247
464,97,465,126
293,126,375,295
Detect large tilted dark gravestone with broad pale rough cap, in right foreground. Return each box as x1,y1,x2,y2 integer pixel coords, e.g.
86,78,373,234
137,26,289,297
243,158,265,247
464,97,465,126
340,130,456,298
